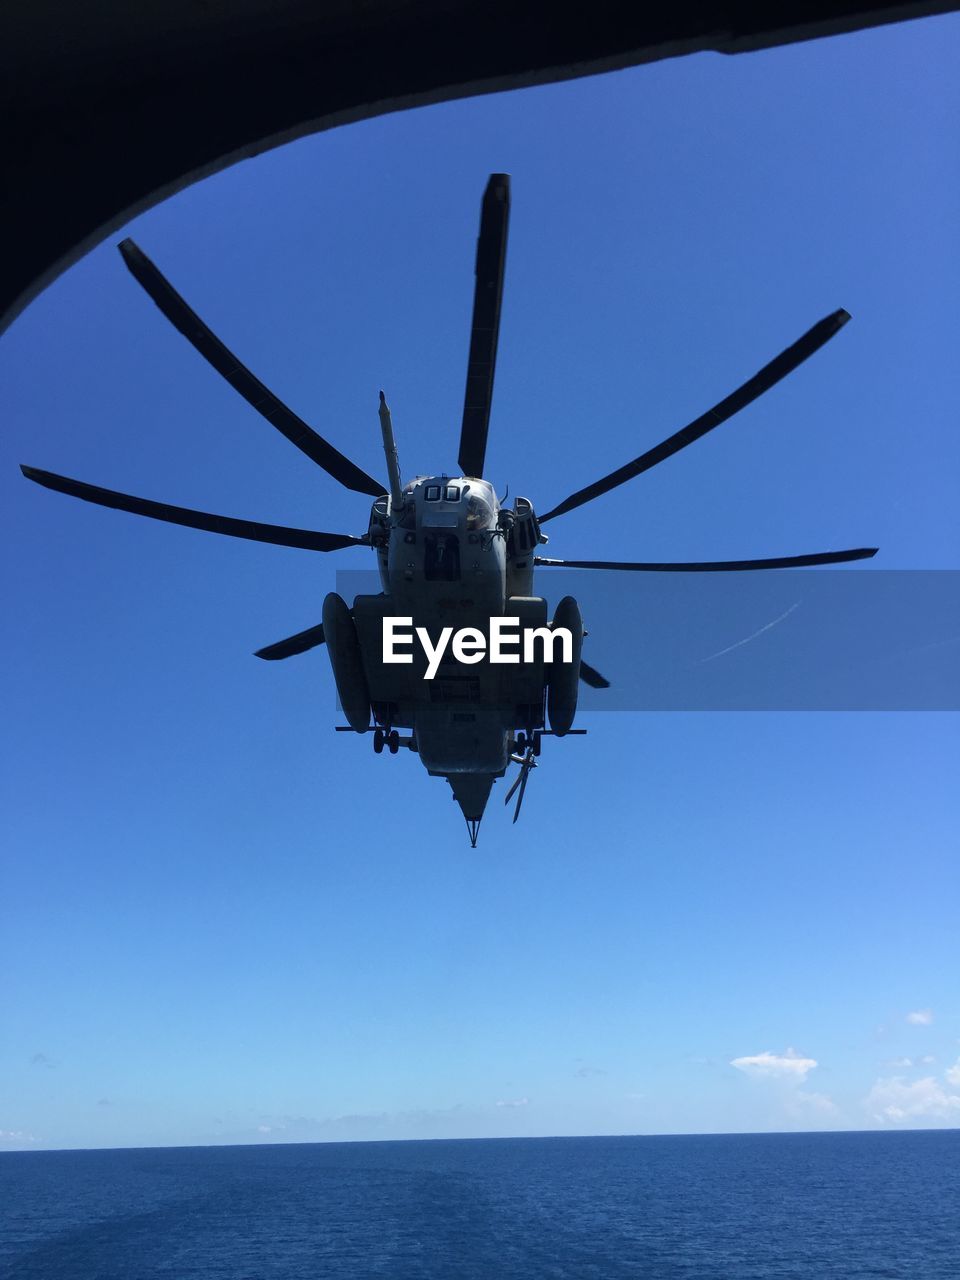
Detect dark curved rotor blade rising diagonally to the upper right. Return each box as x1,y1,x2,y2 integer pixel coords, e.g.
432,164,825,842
539,308,850,524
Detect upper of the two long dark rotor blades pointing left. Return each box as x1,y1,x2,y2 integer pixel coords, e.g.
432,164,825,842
119,239,385,498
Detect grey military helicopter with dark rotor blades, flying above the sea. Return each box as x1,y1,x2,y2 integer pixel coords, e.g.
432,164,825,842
20,174,877,847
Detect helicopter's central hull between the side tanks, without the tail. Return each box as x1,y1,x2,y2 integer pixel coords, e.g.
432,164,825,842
343,476,547,757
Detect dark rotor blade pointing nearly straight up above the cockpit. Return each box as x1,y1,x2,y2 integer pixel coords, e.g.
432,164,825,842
458,173,509,477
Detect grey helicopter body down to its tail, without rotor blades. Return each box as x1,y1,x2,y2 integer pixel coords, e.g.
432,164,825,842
324,475,568,837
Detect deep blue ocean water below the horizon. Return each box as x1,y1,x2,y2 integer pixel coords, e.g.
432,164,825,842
0,1130,960,1280
